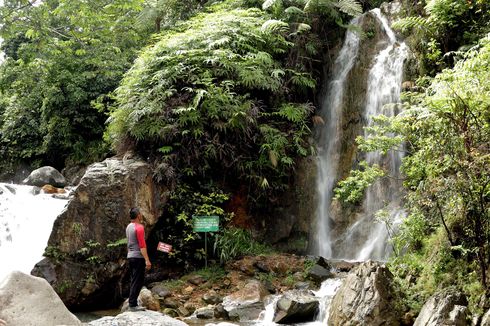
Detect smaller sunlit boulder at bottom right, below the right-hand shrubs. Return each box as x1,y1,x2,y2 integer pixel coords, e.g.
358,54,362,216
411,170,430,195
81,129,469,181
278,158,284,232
414,289,471,326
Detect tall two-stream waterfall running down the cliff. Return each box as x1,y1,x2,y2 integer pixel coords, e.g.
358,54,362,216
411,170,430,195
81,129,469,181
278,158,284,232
315,9,408,260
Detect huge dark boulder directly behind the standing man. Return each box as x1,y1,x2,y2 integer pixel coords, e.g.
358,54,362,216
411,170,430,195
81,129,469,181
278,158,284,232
32,158,166,309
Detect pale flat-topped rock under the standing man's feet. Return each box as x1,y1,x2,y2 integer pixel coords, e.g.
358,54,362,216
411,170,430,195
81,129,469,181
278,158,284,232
88,311,187,326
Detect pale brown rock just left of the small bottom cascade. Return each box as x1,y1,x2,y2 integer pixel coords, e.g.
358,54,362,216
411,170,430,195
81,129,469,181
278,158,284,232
223,280,269,322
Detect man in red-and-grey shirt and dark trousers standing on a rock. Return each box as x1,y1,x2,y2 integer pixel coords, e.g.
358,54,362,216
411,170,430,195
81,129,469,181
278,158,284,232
126,207,151,311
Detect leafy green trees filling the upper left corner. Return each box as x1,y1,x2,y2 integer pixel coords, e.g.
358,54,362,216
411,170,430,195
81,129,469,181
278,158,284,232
0,0,147,169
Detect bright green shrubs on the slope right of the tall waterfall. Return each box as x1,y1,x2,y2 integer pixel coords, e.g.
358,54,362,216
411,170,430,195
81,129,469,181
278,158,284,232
358,36,490,310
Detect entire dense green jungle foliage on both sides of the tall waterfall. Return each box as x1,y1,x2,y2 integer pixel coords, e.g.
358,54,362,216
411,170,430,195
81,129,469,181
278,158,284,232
0,0,490,316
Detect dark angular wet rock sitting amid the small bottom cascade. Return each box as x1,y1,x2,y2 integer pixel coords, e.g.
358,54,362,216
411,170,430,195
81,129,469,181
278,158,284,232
274,291,320,324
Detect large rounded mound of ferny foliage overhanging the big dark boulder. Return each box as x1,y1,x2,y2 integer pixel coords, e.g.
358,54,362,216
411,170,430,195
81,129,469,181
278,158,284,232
107,1,315,201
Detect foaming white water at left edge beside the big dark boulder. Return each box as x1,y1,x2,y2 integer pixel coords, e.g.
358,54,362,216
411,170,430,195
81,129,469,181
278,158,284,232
0,183,68,281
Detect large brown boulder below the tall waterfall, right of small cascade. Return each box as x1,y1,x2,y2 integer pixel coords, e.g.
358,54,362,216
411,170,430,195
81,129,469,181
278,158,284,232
328,261,402,326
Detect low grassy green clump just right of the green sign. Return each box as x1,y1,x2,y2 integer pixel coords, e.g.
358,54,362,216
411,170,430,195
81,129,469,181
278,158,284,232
214,227,272,264
